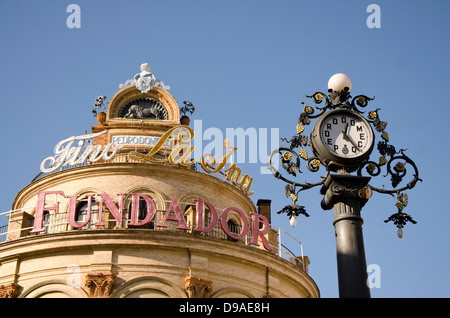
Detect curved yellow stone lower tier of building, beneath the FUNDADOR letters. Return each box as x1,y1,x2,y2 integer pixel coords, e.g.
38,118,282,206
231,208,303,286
0,229,319,298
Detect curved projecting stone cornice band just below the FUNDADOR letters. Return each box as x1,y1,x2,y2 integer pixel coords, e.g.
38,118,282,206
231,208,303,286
0,229,319,297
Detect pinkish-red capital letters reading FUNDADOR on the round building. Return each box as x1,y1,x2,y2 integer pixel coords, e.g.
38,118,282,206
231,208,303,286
31,191,272,251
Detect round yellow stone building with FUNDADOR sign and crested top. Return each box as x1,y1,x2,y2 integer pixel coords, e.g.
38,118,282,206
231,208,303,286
0,62,319,298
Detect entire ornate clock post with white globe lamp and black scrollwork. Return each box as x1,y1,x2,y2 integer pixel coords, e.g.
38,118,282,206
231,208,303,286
269,73,422,298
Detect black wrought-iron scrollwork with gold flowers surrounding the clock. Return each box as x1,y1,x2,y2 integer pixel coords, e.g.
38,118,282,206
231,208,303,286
269,85,422,235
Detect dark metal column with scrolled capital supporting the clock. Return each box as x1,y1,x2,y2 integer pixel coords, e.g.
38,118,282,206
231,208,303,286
320,174,371,298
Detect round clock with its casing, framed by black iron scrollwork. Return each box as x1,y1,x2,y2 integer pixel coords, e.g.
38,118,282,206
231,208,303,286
311,109,374,170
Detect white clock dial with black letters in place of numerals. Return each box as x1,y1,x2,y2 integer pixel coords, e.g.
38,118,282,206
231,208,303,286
320,114,372,158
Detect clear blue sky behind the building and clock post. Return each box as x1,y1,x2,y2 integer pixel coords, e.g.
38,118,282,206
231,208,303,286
0,0,450,297
